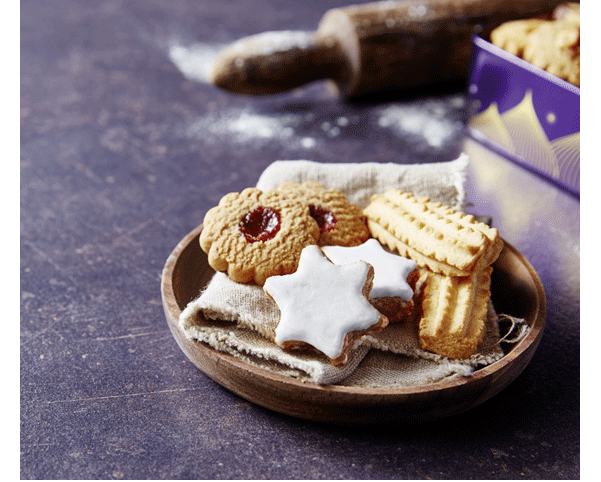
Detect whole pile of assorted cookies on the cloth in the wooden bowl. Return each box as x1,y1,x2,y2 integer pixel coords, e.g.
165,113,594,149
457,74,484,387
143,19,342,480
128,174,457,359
200,182,503,365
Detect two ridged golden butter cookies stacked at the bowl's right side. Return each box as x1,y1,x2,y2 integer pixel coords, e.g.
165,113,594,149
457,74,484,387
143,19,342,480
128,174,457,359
364,189,503,358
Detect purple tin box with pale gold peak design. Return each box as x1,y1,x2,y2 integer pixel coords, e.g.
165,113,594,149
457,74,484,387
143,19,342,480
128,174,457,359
468,36,580,197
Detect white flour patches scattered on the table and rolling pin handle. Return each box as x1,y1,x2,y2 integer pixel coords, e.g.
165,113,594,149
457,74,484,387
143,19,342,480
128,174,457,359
169,38,465,152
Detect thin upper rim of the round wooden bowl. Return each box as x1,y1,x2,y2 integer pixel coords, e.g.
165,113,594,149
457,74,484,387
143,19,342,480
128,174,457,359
161,224,546,400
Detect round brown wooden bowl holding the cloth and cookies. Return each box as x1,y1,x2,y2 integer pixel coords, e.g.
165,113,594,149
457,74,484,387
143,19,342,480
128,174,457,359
161,226,545,423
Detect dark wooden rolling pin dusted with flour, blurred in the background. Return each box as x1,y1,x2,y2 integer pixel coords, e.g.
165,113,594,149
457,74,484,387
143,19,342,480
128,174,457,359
209,0,562,97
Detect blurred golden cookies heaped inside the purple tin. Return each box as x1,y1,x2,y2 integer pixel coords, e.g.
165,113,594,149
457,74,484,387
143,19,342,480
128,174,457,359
490,2,580,87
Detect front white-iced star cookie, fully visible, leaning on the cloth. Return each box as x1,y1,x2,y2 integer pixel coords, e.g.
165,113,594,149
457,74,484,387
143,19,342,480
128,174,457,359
263,246,388,365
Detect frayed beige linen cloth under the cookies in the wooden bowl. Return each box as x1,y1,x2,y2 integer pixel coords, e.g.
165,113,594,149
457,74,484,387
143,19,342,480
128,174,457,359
179,155,521,387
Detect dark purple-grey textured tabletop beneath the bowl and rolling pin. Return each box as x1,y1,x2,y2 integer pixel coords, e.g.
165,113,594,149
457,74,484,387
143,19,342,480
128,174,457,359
21,0,580,479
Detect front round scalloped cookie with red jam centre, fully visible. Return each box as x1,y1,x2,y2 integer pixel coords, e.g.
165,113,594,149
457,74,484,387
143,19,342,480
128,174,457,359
200,188,319,285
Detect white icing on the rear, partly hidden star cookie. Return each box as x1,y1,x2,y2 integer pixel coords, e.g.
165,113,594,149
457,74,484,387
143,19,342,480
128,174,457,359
322,238,417,301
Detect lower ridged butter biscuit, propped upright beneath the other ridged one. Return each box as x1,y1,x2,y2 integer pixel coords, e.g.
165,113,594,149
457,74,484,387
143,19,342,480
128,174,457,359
419,267,492,359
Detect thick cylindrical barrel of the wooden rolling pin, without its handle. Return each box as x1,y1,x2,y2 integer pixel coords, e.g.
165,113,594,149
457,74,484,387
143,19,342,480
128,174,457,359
318,0,562,97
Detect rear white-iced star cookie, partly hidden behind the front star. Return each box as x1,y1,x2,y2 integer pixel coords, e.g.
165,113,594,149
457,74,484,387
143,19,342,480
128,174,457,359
322,238,419,323
